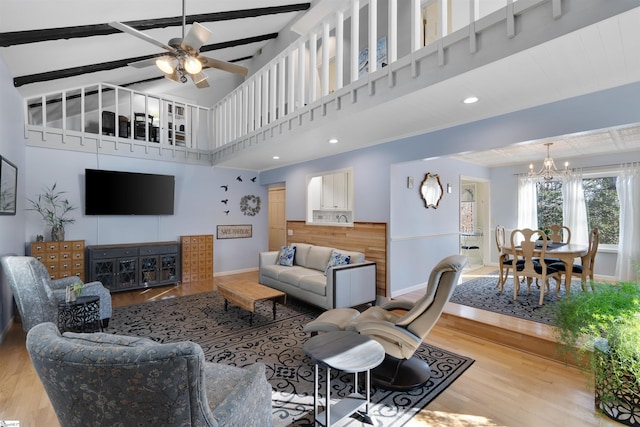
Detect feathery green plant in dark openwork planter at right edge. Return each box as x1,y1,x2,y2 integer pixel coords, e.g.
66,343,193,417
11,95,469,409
556,282,640,426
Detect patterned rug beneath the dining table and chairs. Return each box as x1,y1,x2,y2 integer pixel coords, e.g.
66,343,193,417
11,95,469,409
450,271,581,325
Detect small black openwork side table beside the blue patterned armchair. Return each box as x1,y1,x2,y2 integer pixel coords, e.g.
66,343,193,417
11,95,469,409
58,295,102,333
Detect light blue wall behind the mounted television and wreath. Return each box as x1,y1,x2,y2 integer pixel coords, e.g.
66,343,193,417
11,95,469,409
24,147,267,273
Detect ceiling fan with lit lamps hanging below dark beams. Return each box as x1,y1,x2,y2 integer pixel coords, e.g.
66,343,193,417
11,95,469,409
109,0,248,88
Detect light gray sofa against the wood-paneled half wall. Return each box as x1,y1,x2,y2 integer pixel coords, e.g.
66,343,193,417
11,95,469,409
259,243,376,310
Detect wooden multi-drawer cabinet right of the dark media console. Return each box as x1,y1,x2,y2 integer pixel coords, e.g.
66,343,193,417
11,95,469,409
180,234,213,283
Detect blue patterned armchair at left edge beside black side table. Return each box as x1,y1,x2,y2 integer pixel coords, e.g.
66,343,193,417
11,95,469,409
0,256,111,332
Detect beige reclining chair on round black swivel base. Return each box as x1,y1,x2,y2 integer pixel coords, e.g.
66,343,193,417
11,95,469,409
347,255,467,390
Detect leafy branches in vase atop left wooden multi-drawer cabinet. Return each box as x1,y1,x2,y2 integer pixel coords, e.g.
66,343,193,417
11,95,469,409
27,182,76,241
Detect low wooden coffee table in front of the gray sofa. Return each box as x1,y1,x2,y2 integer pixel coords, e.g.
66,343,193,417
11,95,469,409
218,280,287,325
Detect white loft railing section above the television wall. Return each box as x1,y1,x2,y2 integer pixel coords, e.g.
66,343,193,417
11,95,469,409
24,83,213,163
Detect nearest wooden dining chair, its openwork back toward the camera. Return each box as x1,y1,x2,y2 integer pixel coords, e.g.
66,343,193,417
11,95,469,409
510,228,556,305
